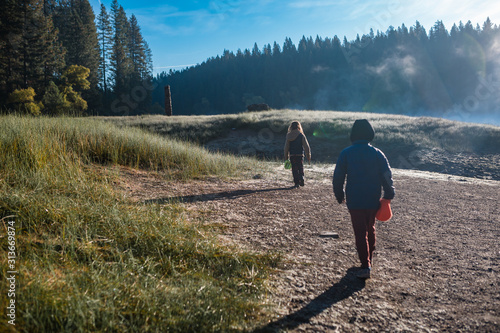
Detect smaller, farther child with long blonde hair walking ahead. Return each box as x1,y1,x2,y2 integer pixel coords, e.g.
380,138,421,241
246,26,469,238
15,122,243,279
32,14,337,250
285,121,311,187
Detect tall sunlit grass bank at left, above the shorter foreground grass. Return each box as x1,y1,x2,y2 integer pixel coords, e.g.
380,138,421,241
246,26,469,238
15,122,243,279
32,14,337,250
0,117,262,179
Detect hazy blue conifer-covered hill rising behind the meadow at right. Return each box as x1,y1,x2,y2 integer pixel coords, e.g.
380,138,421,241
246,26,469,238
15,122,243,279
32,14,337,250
153,18,500,122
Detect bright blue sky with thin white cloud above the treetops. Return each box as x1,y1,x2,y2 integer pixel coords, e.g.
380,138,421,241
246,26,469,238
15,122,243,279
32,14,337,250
90,0,500,74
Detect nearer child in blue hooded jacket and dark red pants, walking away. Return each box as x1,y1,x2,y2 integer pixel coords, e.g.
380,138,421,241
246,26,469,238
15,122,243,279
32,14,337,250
333,119,394,278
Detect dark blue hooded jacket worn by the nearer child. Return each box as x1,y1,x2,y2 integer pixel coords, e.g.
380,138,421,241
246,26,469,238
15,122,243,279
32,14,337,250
333,119,394,209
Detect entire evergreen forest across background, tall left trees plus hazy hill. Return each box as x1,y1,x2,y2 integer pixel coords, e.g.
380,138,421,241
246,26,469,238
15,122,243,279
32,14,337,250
0,0,500,121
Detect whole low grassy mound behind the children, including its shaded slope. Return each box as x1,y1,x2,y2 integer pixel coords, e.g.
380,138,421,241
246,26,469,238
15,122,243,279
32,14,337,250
102,110,500,179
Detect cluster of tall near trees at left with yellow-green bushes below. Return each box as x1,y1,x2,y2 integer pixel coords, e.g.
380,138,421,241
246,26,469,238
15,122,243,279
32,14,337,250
0,0,153,114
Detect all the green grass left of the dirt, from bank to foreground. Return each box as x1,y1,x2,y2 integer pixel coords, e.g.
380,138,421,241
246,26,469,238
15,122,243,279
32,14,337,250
0,116,275,332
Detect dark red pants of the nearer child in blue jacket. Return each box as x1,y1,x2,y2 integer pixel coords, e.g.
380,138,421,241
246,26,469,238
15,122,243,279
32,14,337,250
349,209,377,268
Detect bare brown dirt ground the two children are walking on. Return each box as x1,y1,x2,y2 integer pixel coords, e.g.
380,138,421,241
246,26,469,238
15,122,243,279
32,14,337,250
123,167,500,332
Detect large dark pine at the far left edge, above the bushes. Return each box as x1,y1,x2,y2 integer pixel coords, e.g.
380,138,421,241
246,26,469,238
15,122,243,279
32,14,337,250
0,0,64,104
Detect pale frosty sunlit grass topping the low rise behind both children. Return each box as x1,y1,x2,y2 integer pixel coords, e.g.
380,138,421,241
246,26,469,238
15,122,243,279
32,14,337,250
104,110,500,154
